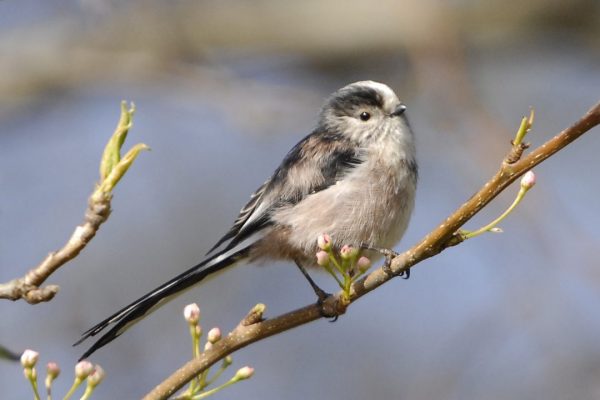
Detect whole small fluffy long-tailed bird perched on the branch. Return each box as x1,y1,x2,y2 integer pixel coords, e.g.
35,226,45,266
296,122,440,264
75,81,417,359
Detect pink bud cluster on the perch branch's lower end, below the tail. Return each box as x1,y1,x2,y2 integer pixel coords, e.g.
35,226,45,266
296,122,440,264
180,303,254,399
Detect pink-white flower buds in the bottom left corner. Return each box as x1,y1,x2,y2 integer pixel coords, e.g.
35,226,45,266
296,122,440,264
21,350,105,400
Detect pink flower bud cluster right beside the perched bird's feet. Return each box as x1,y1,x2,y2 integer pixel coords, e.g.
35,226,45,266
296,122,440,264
316,233,371,297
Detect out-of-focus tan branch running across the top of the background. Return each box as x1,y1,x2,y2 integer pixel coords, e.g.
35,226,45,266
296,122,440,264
0,0,600,129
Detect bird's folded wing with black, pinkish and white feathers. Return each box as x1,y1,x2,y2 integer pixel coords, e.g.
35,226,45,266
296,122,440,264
209,132,363,253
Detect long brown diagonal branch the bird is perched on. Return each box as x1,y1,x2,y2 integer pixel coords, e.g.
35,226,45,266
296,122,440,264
144,103,600,400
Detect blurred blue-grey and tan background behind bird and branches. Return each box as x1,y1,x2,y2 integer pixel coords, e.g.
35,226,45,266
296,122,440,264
0,0,600,400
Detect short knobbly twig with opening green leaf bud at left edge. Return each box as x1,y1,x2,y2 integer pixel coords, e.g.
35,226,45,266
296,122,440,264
0,102,148,304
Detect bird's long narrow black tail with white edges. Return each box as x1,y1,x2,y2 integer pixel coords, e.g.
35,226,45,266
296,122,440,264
73,245,252,361
